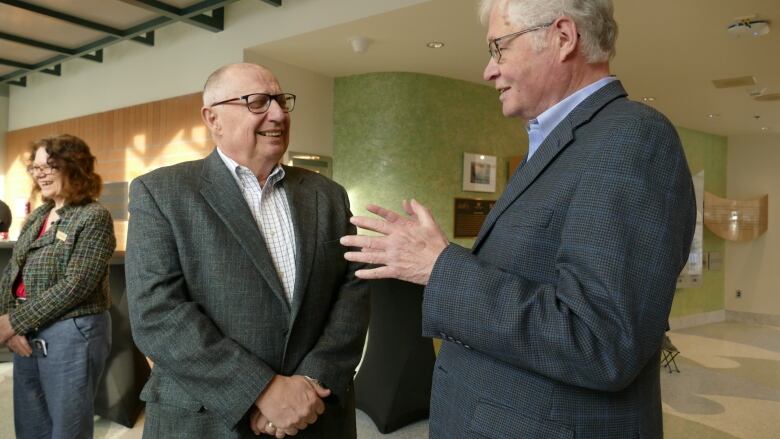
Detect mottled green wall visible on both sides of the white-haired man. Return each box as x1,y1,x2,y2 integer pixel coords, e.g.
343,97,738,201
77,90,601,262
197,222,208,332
333,73,727,317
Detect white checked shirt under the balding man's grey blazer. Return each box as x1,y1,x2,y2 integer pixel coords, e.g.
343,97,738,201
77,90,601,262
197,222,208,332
217,148,296,303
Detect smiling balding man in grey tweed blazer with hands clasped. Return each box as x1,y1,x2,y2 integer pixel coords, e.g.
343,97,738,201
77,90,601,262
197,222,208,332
126,64,369,439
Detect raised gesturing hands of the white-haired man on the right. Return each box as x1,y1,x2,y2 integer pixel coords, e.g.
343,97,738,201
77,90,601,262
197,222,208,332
340,200,449,285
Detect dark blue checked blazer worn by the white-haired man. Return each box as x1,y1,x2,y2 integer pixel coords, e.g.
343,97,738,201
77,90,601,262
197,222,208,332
423,81,696,439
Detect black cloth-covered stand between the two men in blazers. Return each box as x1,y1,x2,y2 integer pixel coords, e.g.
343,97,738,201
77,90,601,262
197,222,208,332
355,279,436,433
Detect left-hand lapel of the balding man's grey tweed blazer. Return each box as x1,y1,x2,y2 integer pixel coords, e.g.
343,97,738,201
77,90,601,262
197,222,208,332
200,149,289,307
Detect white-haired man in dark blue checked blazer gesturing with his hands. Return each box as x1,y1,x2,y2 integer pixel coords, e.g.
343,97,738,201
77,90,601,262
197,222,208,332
342,0,696,439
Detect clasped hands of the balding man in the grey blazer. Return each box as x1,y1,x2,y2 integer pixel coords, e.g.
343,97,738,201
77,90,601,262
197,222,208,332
249,375,330,439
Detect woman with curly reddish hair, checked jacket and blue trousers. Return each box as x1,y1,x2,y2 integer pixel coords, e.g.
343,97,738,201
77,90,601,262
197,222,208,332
0,134,116,439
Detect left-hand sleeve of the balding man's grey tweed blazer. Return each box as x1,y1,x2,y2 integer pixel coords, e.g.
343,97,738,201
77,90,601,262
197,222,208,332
126,178,275,426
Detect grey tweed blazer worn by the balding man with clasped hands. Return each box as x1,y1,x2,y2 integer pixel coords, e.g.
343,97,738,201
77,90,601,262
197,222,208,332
126,149,369,438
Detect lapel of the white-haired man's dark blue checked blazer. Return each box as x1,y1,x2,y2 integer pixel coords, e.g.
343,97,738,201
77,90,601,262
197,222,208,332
472,81,626,252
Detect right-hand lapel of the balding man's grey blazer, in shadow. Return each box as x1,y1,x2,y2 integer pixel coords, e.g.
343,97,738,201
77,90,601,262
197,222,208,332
284,166,318,322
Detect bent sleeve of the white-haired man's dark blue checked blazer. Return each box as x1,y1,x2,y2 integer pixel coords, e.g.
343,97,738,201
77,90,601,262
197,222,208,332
423,110,696,391
